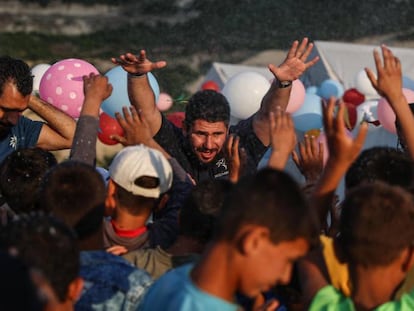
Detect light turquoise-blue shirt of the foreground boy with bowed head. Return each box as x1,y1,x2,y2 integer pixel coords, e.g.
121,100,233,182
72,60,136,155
138,264,240,311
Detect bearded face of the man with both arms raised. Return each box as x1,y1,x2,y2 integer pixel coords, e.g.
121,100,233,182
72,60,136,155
188,120,228,163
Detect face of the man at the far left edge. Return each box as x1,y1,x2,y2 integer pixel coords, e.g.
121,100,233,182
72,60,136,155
0,82,30,137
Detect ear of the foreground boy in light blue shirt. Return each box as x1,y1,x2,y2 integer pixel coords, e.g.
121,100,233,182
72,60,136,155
236,226,270,256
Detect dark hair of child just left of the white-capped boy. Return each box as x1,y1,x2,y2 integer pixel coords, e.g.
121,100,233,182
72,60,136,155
38,160,106,239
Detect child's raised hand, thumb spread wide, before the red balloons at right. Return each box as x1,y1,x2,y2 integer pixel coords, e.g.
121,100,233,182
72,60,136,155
323,97,368,165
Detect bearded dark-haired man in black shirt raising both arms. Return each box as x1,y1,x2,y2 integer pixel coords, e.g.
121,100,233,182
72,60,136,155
112,38,318,181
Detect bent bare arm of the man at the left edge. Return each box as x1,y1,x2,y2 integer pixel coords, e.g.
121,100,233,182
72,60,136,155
29,95,76,150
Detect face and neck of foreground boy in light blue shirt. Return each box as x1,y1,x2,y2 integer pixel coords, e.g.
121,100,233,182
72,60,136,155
239,238,309,297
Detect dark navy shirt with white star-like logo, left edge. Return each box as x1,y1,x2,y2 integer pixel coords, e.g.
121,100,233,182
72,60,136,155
0,116,44,162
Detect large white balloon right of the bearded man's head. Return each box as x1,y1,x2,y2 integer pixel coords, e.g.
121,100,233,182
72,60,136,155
222,71,270,120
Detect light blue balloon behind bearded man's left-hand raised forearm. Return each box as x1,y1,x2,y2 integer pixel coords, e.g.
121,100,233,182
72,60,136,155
102,66,160,118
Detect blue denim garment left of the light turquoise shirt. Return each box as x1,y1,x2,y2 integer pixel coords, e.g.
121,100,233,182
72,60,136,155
75,251,152,311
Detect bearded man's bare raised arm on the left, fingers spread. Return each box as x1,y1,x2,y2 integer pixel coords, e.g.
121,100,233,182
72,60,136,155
111,50,167,136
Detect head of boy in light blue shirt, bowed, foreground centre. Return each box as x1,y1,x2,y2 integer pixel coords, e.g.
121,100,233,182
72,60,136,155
216,168,319,297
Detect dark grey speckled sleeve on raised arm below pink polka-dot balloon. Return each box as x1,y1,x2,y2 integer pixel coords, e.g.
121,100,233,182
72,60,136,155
70,116,99,166
